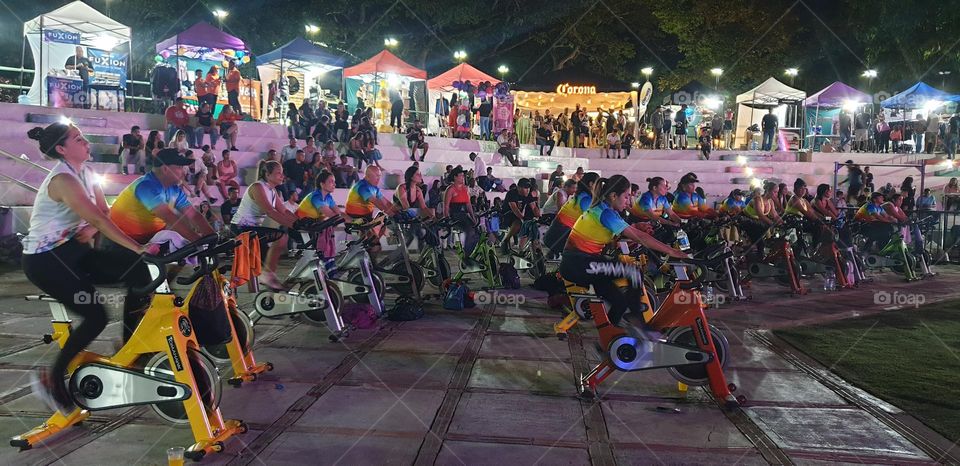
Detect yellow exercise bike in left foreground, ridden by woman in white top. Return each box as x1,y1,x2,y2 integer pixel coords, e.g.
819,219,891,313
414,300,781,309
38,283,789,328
10,235,247,460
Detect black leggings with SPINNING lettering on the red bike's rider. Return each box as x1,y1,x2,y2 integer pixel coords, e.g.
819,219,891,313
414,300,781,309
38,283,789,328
560,250,643,326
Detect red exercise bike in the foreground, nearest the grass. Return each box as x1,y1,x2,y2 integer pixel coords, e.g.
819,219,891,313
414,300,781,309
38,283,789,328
568,253,745,408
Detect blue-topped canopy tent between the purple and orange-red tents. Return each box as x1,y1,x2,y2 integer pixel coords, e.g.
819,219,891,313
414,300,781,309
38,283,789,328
257,37,344,121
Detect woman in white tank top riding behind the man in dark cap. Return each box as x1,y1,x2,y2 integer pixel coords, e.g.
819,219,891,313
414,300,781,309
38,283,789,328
231,160,297,290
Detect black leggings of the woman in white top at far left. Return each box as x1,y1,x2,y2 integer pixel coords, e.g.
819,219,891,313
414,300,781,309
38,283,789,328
22,240,152,380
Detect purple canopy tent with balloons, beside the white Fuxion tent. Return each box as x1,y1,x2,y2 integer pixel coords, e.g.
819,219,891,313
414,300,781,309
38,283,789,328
156,21,260,118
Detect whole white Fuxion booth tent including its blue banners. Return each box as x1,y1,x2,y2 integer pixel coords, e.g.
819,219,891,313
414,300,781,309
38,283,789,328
20,0,130,109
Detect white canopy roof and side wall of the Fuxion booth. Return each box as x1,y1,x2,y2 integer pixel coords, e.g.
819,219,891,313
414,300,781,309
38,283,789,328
20,0,131,105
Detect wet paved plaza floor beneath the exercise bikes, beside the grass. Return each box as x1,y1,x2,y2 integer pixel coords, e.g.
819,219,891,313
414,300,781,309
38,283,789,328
0,260,960,465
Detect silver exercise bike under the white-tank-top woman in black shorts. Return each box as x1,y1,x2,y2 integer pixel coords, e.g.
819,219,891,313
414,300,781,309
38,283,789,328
250,216,370,342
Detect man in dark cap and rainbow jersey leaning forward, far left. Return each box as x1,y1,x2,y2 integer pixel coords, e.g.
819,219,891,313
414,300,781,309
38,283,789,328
108,149,215,282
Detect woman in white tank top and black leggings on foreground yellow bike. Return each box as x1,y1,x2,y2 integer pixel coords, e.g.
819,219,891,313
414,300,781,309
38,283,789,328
22,123,157,414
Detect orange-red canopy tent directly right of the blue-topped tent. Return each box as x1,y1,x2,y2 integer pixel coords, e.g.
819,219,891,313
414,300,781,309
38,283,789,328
343,50,428,132
